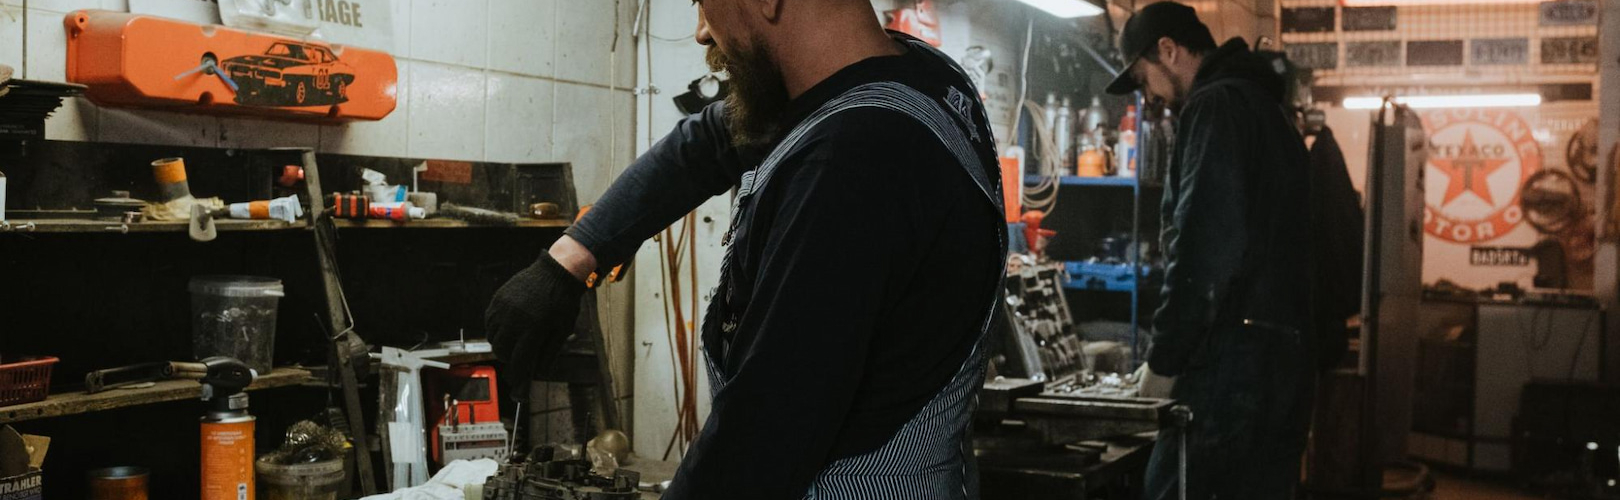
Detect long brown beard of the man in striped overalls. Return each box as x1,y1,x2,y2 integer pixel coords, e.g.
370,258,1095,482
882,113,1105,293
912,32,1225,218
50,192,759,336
708,40,789,149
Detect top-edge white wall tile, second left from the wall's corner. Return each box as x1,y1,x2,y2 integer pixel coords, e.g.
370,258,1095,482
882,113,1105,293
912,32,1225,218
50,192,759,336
488,0,554,76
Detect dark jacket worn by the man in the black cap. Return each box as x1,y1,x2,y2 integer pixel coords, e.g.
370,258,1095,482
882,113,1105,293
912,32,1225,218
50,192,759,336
1149,39,1312,375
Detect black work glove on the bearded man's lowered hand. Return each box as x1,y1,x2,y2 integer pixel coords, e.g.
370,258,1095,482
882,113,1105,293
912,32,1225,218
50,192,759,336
484,254,586,401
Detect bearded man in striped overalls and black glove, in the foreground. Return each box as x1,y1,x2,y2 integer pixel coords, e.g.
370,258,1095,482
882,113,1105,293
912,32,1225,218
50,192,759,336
486,0,1006,498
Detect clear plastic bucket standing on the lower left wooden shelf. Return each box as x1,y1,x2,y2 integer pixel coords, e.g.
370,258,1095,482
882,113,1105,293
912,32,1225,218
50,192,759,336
190,275,285,375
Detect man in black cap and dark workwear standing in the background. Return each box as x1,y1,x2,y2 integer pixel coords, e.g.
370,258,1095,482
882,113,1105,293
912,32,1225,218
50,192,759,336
1108,2,1315,498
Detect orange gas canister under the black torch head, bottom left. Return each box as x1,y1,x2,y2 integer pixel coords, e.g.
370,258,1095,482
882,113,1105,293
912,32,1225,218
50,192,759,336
203,393,254,500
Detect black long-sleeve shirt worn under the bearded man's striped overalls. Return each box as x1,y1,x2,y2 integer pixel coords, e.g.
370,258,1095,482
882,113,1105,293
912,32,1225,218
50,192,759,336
570,33,1004,498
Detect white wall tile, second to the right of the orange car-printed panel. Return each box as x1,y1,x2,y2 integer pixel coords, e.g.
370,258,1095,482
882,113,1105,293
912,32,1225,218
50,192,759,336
484,73,556,162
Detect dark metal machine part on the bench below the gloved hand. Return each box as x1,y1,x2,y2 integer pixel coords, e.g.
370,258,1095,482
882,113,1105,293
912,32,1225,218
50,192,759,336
484,447,642,500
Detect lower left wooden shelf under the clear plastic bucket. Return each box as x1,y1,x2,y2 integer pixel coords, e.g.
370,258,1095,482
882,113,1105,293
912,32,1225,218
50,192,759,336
0,367,309,424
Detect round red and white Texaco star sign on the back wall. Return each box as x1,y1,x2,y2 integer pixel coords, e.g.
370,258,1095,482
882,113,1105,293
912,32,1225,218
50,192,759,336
1422,108,1541,244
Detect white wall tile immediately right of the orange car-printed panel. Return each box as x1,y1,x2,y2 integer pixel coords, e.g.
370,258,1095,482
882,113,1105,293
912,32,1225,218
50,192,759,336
405,61,486,159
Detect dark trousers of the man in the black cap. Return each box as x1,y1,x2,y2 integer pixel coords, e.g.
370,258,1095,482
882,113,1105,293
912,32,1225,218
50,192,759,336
1144,327,1317,500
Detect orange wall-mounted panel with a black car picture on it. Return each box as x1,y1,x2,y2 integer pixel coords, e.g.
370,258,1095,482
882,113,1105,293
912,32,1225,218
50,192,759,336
62,10,399,121
